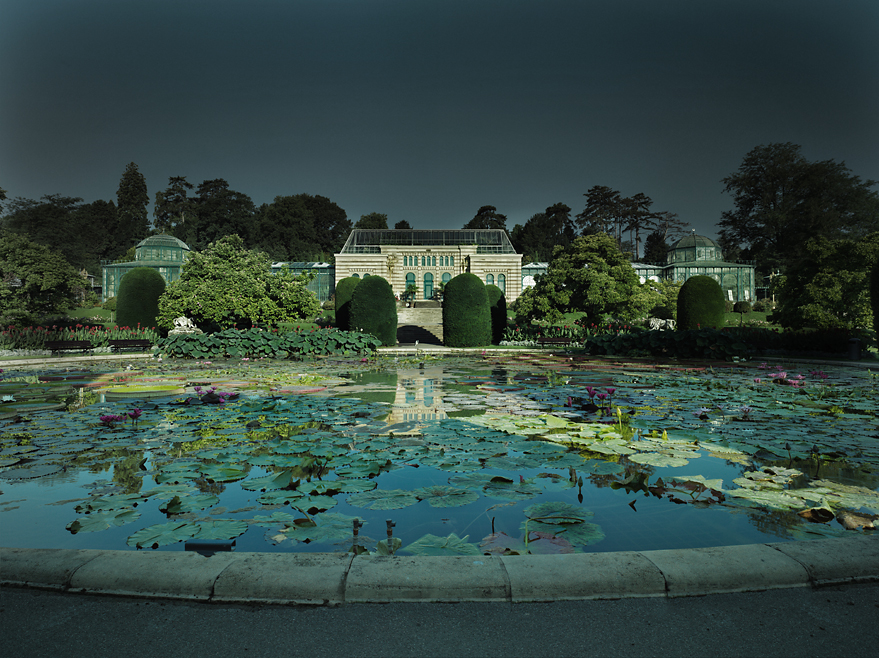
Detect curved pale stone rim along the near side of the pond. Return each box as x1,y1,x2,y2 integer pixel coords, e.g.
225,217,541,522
0,534,879,606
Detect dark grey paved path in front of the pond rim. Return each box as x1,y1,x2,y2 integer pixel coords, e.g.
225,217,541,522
0,584,879,658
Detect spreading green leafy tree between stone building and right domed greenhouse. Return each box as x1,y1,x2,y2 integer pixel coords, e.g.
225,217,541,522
513,233,660,324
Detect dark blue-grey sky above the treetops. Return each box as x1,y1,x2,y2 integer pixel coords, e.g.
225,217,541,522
0,0,879,237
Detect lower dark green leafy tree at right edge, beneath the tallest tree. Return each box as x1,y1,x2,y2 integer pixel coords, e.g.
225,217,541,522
773,232,879,329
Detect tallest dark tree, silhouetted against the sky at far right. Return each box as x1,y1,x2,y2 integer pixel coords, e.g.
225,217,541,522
718,142,879,274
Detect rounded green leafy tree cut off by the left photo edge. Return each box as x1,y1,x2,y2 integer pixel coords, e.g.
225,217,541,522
0,231,88,325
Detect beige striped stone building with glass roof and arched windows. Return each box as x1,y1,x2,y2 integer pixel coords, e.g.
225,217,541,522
335,229,522,303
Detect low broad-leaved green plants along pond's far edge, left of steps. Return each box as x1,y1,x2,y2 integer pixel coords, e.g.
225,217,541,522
156,329,381,359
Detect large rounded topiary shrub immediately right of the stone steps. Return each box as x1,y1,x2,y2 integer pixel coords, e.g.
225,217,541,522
443,272,491,347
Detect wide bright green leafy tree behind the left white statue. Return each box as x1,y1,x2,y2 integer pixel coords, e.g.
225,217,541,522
158,235,320,330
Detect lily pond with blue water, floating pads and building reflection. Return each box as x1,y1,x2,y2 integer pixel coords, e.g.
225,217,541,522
0,354,879,555
